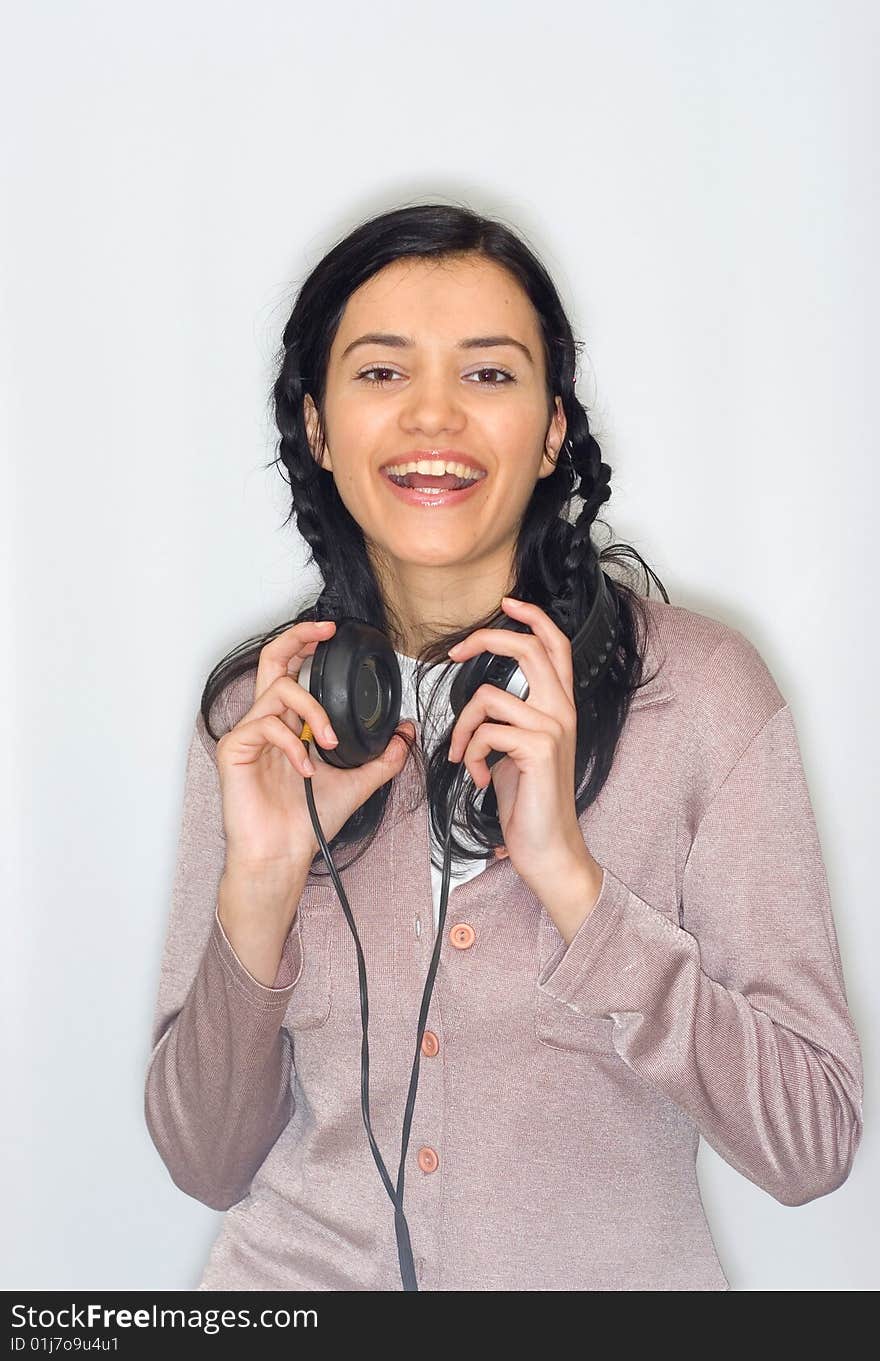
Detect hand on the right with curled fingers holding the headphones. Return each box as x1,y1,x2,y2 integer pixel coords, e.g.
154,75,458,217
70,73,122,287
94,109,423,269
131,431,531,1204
449,596,598,898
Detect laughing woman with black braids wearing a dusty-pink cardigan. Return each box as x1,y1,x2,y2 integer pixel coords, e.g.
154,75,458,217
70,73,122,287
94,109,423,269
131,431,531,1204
146,204,862,1290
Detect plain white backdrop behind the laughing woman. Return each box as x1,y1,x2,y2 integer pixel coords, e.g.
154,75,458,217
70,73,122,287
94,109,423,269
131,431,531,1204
0,0,880,1290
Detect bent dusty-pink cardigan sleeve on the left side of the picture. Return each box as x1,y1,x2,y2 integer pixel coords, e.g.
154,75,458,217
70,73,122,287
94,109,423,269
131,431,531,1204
144,715,305,1210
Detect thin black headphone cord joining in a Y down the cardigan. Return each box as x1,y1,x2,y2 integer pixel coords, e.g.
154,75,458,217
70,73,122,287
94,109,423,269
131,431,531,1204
301,728,470,1290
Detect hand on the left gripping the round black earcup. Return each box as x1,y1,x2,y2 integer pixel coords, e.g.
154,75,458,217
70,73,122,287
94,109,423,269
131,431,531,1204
216,621,415,879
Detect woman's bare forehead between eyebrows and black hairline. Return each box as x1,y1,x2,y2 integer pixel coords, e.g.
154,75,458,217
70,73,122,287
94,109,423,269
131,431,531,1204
331,256,540,357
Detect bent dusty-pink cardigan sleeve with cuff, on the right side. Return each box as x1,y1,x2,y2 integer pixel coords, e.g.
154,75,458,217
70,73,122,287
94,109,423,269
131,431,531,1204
539,705,862,1206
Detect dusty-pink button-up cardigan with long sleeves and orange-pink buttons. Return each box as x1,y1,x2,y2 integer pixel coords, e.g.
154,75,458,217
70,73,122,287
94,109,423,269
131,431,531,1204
144,600,862,1290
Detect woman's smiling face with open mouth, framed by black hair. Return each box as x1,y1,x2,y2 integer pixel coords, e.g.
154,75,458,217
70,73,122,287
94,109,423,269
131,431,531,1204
305,256,566,593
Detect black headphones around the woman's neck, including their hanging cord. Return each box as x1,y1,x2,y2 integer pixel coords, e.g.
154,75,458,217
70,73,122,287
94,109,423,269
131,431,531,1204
292,561,619,1290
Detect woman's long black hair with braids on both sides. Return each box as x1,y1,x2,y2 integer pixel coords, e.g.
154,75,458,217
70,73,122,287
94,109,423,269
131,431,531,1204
201,203,669,870
